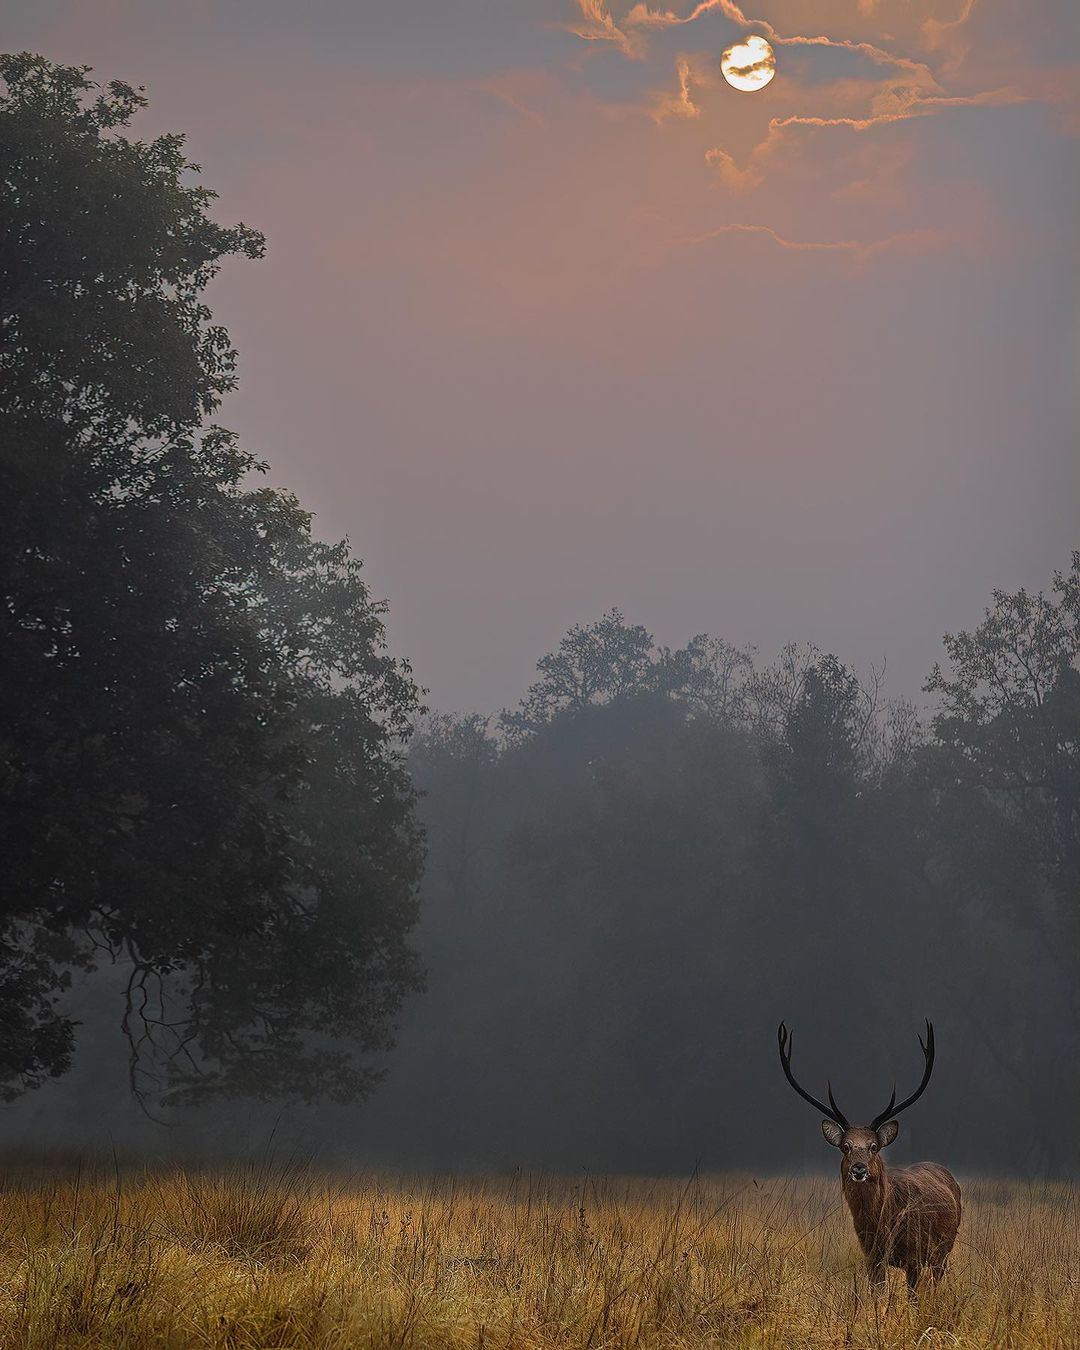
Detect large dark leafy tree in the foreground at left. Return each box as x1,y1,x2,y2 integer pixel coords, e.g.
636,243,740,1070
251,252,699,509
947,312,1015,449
0,55,421,1099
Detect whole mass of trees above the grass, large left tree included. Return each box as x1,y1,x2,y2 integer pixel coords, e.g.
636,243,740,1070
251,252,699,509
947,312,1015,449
0,54,1080,1172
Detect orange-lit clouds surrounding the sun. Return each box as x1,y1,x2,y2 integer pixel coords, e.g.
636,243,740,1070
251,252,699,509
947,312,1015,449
561,0,1069,263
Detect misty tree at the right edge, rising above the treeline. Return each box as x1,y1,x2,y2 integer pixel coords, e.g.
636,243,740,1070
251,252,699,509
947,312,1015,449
922,554,1080,1170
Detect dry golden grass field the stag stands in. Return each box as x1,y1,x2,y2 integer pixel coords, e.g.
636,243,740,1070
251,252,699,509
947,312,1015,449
0,1165,1080,1350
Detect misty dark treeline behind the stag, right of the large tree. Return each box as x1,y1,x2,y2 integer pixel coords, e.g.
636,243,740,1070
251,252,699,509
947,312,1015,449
366,585,1080,1172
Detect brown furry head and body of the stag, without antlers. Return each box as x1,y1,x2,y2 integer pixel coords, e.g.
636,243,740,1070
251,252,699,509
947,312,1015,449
840,1122,960,1291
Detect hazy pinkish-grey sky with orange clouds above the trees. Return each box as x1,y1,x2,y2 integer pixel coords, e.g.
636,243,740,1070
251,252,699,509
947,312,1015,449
0,0,1080,711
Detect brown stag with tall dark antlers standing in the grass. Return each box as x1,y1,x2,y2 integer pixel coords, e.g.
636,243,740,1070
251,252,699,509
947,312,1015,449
778,1019,960,1293
